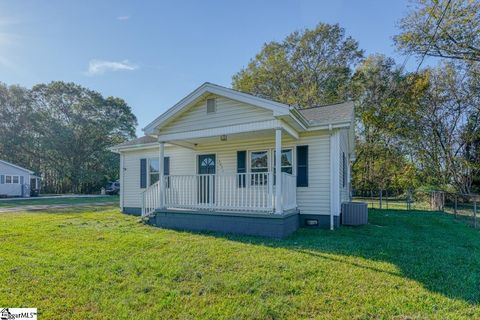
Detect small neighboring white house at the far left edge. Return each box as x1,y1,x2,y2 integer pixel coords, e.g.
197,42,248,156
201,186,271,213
0,160,40,197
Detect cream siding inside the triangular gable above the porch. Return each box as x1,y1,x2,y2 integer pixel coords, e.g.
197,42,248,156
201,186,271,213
160,97,273,134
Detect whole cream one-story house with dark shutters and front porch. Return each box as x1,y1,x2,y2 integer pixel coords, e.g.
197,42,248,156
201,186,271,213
112,83,354,236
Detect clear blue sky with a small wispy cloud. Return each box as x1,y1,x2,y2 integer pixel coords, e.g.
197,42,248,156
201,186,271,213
0,0,415,136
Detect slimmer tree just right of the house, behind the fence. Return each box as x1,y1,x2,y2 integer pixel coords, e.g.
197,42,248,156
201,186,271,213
352,55,417,192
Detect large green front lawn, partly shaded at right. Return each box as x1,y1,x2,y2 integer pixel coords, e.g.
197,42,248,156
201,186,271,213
0,207,480,319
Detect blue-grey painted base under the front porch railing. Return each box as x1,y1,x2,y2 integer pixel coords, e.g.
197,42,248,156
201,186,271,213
148,209,299,238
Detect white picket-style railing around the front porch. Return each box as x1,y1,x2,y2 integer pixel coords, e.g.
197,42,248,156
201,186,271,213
142,172,297,215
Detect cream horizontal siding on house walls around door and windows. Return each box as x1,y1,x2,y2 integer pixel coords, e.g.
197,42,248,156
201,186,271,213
122,129,330,215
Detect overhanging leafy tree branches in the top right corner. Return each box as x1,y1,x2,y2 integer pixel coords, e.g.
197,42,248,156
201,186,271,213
394,0,480,62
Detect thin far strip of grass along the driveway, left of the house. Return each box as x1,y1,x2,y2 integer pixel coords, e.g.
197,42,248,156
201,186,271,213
0,196,118,208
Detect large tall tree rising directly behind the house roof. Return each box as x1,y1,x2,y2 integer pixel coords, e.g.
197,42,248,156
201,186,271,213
232,23,363,107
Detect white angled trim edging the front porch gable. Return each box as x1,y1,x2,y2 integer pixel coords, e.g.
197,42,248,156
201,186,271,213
143,82,290,135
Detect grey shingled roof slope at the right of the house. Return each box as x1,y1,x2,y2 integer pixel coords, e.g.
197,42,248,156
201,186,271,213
297,101,354,126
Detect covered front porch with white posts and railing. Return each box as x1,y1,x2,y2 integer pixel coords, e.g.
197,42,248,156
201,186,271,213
142,120,299,216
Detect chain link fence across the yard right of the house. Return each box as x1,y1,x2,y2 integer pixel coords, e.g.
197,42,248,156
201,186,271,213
352,190,480,228
